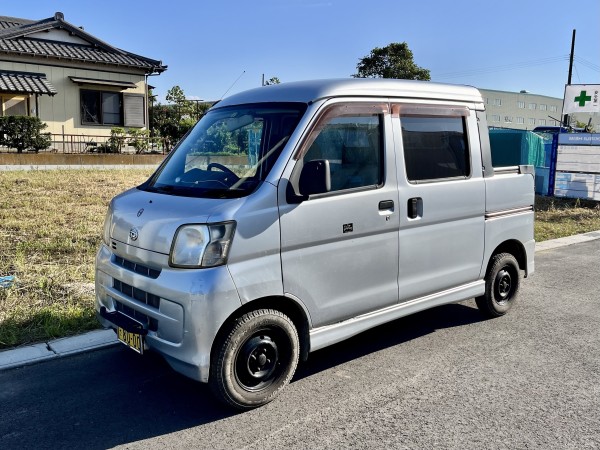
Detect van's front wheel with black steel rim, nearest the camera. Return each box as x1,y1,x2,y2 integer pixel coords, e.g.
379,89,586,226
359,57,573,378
208,309,300,410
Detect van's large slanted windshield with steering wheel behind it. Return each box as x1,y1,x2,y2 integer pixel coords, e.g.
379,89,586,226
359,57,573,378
140,103,306,198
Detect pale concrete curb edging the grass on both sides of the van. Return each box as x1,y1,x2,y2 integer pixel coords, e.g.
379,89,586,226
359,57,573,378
0,230,600,371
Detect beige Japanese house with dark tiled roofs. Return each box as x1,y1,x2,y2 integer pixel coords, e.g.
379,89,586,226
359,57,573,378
0,12,167,151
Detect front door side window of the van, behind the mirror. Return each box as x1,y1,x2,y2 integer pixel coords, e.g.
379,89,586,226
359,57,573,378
303,113,383,191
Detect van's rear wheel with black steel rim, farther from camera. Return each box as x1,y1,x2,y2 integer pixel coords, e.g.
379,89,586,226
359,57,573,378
475,253,521,318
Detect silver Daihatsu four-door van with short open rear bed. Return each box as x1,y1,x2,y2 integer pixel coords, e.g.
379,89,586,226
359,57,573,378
96,79,534,409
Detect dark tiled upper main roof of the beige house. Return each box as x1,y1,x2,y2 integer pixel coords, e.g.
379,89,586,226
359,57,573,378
0,13,167,73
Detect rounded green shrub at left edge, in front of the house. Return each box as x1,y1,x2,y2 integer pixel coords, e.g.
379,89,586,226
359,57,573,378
0,116,51,153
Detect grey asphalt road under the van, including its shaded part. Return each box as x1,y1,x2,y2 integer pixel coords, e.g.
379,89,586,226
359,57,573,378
0,240,600,450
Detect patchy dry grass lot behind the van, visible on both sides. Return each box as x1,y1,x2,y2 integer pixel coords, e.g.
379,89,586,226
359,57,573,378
0,169,600,349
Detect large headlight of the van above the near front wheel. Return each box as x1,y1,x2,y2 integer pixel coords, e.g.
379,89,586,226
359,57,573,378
169,222,235,268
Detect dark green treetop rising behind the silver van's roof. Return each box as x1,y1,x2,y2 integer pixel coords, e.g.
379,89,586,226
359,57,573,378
352,42,431,81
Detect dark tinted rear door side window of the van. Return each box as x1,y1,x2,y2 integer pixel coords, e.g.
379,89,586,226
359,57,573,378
400,108,471,182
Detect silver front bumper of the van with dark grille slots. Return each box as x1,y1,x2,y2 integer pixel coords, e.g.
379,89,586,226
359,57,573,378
96,243,241,382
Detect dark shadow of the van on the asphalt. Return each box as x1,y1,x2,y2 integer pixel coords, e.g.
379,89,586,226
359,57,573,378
0,303,482,449
